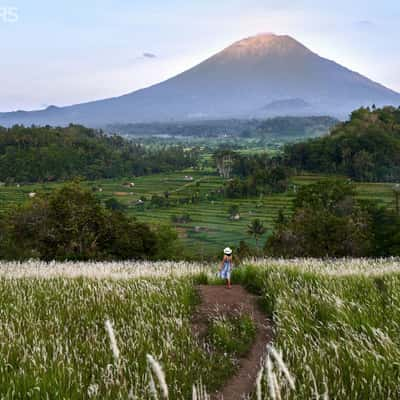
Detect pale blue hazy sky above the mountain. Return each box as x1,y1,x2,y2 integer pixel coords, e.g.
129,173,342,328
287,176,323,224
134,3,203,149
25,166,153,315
0,0,400,111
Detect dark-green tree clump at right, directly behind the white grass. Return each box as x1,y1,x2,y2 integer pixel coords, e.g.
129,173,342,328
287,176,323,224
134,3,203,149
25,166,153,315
264,180,400,257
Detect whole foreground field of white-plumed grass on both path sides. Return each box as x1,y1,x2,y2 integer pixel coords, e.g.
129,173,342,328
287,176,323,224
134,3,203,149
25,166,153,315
0,259,400,399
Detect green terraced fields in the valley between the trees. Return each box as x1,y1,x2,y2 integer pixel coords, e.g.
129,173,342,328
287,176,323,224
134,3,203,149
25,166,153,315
0,171,394,258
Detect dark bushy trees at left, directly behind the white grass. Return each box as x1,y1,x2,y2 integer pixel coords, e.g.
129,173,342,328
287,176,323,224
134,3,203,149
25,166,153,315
0,183,182,261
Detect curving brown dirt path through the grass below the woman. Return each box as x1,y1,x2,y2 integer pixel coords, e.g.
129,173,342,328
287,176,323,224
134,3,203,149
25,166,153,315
193,285,272,400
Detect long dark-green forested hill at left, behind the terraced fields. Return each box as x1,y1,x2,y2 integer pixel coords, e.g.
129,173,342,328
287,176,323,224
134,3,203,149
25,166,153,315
0,125,196,182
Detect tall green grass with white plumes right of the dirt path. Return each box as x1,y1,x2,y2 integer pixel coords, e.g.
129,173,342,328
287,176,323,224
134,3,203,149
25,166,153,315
234,260,400,400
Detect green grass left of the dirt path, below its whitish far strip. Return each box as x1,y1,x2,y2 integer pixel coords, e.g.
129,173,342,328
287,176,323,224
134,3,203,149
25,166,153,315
0,278,238,399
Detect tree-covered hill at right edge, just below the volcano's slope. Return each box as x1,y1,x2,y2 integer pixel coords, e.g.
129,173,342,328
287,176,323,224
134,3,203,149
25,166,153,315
285,107,400,182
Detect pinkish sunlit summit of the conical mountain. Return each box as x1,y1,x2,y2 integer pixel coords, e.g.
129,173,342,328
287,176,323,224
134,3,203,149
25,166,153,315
222,33,311,57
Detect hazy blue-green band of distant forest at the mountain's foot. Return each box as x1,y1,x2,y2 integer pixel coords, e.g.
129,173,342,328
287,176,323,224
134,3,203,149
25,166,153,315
107,117,338,139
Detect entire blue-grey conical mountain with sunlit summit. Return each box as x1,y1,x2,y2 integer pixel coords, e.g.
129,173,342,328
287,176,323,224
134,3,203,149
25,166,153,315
0,34,400,126
